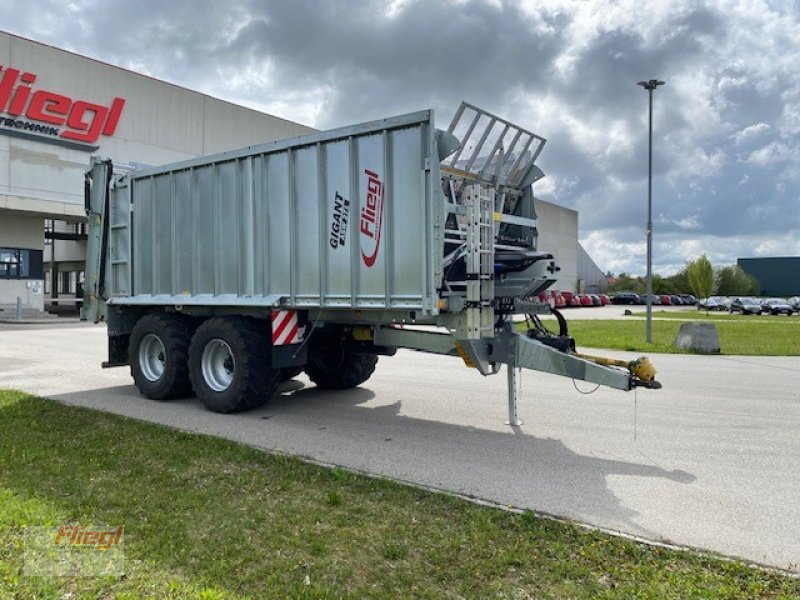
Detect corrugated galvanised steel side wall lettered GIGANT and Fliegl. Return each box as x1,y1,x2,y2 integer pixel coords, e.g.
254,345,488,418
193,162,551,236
113,111,444,314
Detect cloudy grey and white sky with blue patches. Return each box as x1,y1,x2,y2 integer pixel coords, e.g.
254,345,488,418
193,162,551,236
0,0,800,274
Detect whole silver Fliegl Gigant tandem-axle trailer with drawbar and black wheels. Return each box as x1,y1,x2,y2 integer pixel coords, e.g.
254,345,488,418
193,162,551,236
83,103,659,424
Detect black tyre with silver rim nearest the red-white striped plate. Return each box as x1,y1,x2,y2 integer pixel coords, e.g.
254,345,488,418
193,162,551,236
189,317,280,413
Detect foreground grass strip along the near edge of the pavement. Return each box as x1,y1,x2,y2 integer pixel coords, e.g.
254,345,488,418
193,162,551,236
0,391,800,599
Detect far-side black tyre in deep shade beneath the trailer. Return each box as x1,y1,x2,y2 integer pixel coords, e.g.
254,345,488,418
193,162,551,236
306,333,378,390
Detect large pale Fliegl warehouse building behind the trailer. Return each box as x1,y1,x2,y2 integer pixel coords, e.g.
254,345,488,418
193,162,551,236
0,32,599,315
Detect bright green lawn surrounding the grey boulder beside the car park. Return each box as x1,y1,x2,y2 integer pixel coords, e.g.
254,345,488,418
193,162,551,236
532,311,800,356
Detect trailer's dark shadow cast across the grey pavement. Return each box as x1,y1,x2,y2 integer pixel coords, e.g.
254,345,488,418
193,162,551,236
45,380,696,539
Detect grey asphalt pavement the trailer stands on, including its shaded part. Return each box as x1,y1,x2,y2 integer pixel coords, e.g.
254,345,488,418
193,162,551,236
0,318,800,571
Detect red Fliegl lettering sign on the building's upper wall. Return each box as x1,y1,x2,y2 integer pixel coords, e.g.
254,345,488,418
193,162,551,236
0,65,125,152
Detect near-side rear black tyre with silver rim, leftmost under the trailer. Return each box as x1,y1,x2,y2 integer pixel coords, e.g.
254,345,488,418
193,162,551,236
128,315,192,400
